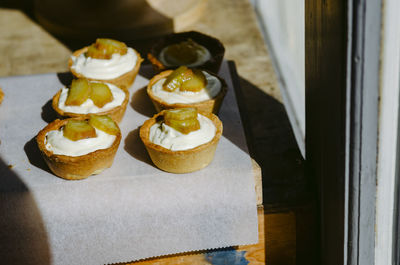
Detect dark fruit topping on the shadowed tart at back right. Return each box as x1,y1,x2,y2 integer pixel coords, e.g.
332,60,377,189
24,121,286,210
164,39,201,65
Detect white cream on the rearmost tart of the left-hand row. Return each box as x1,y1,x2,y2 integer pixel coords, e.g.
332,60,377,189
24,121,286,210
71,48,138,80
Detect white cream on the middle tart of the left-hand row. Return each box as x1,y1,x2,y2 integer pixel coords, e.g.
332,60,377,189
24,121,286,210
58,83,126,114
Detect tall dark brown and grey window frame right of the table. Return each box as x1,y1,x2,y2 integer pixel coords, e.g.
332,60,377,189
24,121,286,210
305,0,382,265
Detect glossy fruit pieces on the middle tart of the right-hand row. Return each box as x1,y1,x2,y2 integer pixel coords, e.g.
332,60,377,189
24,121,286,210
163,66,207,92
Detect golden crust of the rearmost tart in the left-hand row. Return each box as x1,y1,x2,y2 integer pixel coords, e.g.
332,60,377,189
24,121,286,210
68,46,143,88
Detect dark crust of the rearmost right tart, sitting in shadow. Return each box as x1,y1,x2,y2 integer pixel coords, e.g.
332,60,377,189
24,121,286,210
147,31,225,73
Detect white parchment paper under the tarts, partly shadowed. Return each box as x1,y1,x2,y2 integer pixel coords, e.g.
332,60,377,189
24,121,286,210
0,62,258,265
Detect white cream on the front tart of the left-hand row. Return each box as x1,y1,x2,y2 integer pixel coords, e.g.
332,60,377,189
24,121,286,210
44,128,116,156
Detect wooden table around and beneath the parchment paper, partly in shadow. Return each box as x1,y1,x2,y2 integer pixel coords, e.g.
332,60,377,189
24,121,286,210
0,0,317,265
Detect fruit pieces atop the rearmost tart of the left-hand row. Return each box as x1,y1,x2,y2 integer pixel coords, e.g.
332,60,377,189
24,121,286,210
86,39,128,59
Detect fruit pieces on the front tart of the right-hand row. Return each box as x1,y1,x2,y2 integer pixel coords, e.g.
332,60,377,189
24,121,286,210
164,108,200,134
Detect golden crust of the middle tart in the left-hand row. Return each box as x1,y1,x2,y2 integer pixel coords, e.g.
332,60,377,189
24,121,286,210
51,84,129,123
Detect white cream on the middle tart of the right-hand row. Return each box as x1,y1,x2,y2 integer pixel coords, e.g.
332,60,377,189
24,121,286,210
151,71,222,104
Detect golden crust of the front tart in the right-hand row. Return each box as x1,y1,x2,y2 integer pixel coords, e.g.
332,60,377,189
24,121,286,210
139,111,223,173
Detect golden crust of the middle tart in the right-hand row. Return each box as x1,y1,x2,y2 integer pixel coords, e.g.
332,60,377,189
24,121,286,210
147,70,227,114
